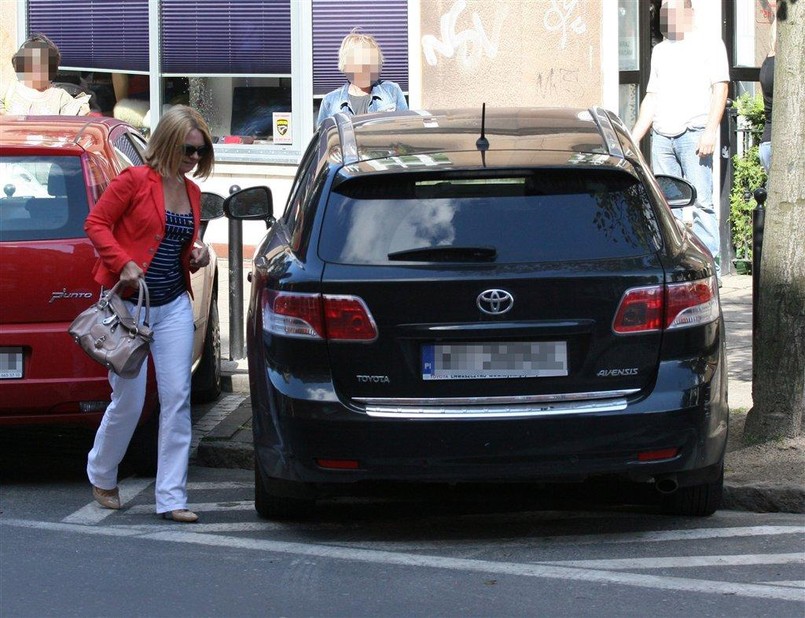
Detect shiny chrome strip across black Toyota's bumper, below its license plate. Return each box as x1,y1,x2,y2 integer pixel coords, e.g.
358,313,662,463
366,399,627,420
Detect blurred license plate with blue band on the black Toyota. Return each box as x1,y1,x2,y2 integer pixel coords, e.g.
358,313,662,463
422,341,567,380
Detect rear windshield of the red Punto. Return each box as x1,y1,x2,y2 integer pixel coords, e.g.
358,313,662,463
0,156,89,241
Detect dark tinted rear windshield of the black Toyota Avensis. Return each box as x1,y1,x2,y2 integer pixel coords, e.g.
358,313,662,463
319,168,660,264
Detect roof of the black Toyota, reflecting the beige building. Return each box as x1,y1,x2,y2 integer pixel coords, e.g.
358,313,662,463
323,107,631,177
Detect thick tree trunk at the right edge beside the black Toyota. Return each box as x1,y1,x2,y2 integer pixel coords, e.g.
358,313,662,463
744,1,805,440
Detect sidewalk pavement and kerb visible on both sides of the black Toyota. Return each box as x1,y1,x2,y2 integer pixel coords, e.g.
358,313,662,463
194,258,805,513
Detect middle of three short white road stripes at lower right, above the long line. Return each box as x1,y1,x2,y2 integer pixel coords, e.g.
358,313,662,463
534,553,805,571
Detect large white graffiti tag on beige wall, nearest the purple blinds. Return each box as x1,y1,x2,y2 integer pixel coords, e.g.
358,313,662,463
422,0,508,67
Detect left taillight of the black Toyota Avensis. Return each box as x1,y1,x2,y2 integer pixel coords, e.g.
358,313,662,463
263,290,377,341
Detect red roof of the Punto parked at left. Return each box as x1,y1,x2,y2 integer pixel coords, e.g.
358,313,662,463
0,116,131,151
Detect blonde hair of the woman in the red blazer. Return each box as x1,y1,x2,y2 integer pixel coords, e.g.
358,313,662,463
145,105,215,178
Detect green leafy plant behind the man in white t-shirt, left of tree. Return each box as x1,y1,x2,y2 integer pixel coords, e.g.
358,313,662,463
730,93,766,261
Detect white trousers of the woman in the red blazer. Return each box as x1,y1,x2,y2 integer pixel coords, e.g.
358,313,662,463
87,294,193,513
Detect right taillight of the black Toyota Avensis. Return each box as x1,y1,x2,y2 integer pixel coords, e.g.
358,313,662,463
612,277,718,335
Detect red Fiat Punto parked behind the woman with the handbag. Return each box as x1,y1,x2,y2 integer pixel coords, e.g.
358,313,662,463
0,116,221,464
